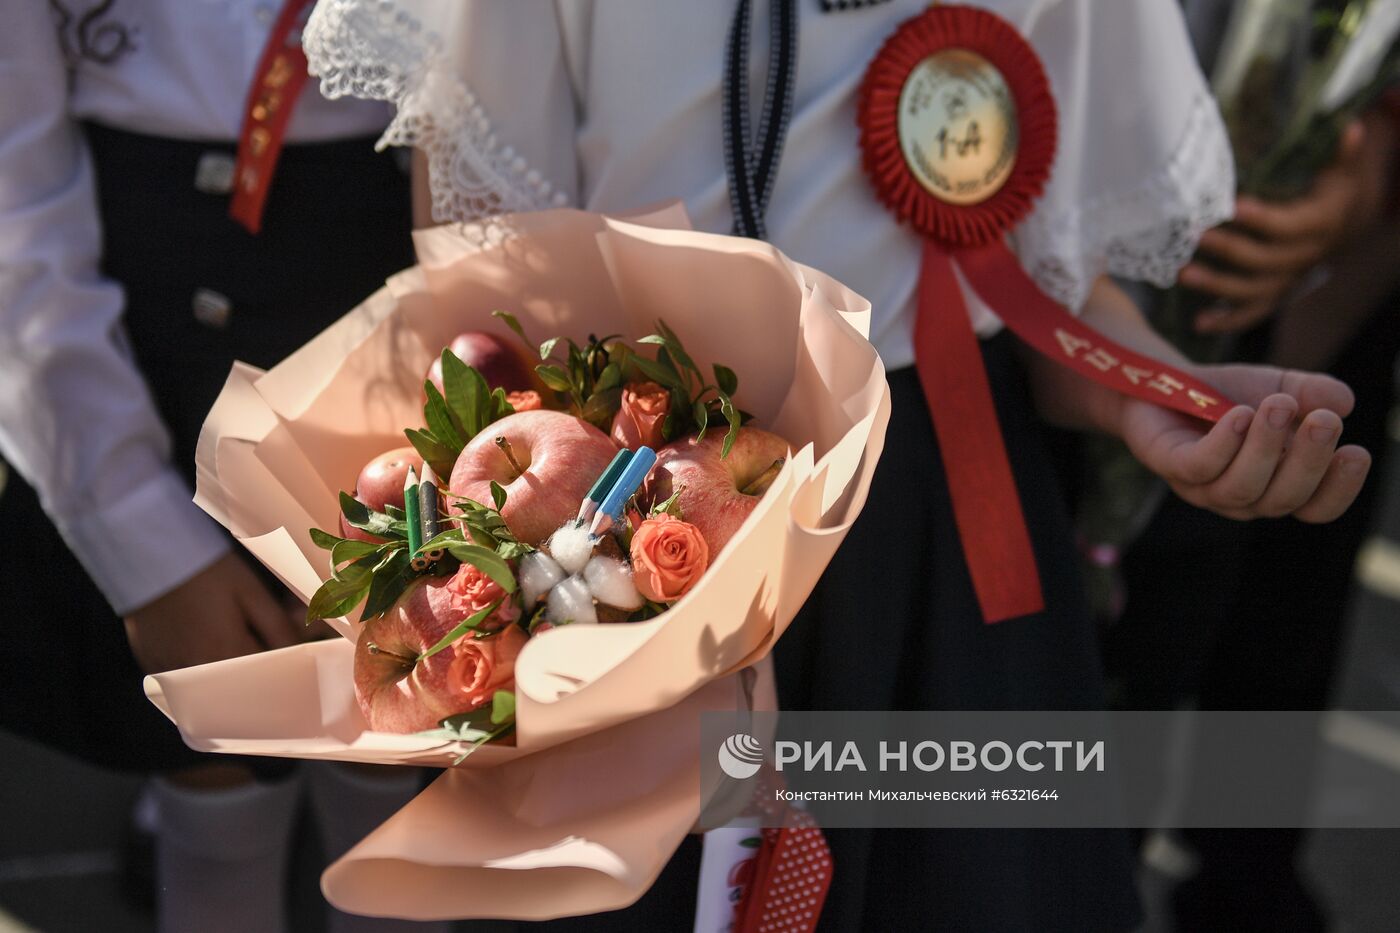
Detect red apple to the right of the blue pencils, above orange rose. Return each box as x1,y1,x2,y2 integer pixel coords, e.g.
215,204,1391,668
648,427,788,562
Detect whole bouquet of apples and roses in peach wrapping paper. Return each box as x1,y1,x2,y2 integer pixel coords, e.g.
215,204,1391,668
147,201,889,919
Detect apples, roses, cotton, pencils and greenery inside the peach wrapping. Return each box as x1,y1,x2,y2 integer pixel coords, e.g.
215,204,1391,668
316,311,790,745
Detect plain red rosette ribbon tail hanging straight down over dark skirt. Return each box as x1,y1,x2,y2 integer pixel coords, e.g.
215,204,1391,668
914,241,1044,623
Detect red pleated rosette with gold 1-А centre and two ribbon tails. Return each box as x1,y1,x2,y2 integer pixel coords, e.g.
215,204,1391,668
858,6,1231,622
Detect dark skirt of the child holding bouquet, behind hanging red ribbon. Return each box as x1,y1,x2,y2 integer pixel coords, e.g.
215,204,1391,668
521,335,1141,933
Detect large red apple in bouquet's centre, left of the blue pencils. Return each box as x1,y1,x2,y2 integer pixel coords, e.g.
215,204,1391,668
448,410,617,545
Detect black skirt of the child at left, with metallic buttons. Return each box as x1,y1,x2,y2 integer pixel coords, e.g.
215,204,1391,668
0,126,413,770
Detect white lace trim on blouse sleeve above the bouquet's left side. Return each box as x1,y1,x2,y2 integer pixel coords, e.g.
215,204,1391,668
302,0,568,221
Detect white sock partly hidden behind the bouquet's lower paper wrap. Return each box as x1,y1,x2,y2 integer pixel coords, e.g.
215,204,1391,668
307,762,452,933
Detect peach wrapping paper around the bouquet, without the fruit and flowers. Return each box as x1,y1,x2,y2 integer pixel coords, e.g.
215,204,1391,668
146,207,889,919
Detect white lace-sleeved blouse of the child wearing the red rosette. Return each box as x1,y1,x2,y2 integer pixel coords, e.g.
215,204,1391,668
305,0,1235,368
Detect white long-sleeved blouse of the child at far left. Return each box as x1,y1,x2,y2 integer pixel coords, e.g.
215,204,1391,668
0,0,389,612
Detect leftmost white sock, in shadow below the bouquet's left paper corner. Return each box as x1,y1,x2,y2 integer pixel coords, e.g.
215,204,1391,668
153,776,301,933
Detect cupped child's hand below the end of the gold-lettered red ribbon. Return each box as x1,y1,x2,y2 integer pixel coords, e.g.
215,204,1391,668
1119,366,1371,523
